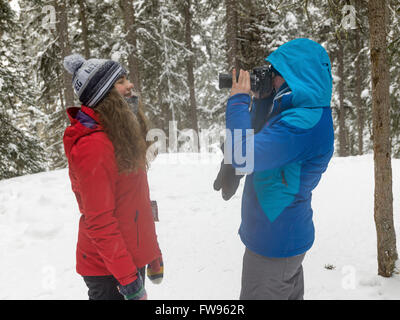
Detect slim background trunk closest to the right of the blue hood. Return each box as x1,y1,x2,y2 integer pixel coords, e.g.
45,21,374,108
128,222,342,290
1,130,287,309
337,35,348,157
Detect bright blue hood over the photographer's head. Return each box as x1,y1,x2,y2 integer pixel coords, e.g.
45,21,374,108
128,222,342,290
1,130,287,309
265,39,332,108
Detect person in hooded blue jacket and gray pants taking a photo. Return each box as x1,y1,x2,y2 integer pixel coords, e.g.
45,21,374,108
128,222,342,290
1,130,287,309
226,39,334,299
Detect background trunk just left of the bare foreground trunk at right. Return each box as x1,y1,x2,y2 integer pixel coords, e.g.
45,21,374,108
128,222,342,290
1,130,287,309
355,0,364,155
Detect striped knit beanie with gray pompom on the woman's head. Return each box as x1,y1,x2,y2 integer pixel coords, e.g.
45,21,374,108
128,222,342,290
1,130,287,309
64,54,126,108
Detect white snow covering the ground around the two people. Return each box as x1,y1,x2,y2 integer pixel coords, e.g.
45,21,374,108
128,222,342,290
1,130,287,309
0,154,400,300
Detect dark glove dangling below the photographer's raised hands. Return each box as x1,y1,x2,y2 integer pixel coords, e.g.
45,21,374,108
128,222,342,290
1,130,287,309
214,160,243,201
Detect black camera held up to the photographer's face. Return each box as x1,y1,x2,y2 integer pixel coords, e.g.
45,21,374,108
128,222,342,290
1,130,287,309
219,65,273,96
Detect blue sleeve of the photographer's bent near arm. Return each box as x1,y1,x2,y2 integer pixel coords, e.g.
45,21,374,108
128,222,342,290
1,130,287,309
226,94,313,173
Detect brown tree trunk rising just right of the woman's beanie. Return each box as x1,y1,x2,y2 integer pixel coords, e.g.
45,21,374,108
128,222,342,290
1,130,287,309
120,0,141,92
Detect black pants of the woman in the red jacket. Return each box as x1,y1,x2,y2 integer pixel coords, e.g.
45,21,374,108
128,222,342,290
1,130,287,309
83,268,146,300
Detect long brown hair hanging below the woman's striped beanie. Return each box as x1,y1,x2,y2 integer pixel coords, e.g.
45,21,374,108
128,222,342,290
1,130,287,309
94,88,147,173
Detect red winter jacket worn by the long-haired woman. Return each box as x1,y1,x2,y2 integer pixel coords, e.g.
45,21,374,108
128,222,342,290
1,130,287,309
63,106,161,285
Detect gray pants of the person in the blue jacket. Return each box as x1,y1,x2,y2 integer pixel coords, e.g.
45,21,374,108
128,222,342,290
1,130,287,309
240,248,306,300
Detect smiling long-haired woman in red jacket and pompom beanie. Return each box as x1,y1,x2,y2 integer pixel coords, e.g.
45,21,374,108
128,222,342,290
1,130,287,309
63,54,163,300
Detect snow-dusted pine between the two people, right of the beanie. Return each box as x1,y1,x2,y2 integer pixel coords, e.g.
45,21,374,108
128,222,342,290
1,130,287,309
136,0,189,132
